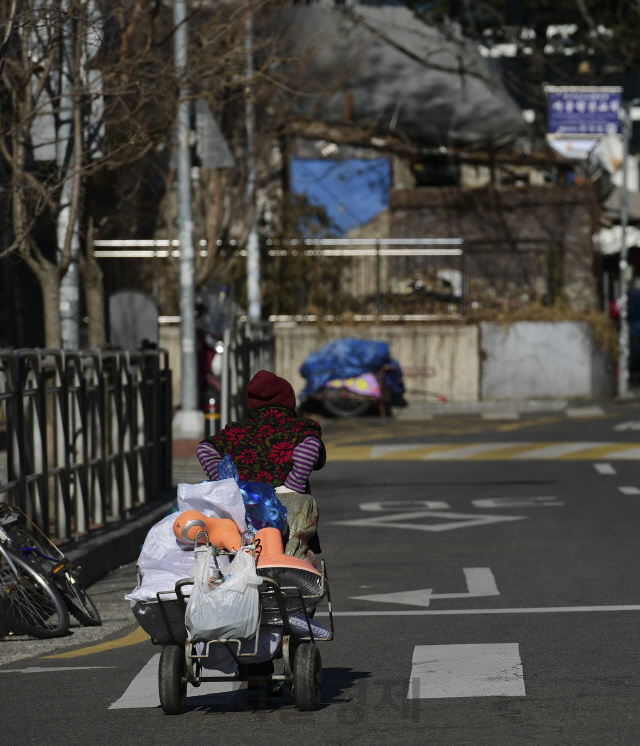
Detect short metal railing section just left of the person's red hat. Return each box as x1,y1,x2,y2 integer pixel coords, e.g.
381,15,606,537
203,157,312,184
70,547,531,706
220,322,275,427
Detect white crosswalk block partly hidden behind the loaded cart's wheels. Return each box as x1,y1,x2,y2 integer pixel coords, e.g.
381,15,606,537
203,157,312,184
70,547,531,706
109,653,240,710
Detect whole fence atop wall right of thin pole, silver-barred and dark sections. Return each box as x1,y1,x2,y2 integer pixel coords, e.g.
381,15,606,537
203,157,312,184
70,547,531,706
268,237,561,321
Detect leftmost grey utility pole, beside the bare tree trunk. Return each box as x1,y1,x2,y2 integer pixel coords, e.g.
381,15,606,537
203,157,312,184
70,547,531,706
56,0,80,350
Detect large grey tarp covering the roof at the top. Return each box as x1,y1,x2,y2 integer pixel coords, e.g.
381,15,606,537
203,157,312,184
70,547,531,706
271,5,526,147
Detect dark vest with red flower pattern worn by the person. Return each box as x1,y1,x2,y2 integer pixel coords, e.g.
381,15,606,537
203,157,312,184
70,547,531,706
202,406,322,487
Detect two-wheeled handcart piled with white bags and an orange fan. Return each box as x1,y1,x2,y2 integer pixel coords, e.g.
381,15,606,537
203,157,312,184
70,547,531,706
127,450,333,714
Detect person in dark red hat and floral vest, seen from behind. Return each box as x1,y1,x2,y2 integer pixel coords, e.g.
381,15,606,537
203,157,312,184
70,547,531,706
198,370,326,566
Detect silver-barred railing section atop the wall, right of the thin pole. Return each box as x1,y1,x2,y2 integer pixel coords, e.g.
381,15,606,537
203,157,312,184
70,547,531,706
267,238,466,321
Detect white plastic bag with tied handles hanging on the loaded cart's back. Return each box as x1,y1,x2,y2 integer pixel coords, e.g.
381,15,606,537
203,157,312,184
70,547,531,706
184,547,262,642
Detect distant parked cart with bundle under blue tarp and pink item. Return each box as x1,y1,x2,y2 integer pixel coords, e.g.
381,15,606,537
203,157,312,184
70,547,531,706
300,339,404,417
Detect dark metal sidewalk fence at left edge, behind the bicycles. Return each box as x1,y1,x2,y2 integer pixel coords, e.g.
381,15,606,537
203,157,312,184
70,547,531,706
0,350,172,540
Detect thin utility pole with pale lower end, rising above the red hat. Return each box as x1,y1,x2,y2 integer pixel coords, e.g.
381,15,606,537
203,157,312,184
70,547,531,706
244,0,262,321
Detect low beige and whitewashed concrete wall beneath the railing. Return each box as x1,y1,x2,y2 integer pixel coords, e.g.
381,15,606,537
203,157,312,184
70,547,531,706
160,321,615,406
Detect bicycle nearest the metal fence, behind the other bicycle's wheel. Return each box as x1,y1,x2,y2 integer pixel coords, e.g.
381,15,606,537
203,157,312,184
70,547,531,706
0,505,102,636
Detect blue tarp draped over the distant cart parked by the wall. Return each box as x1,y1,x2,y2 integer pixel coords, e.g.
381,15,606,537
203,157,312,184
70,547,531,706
300,339,392,396
